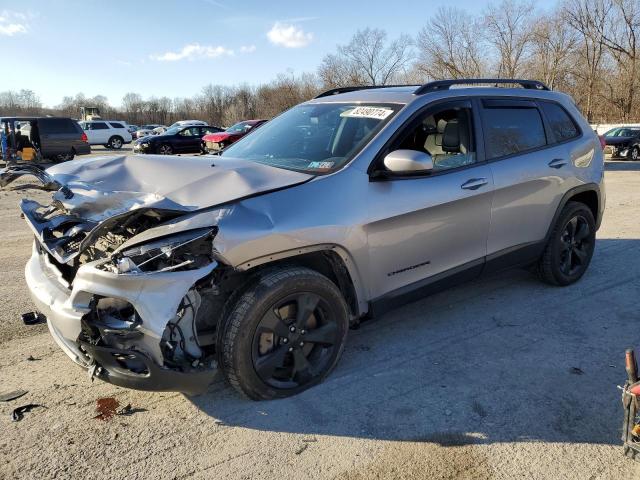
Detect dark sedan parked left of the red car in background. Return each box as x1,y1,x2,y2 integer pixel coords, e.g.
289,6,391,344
133,126,222,155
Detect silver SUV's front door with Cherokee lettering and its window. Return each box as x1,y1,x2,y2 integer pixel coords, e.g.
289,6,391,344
366,101,493,300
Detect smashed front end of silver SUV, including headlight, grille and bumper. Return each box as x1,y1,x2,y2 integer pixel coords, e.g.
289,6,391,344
11,180,225,393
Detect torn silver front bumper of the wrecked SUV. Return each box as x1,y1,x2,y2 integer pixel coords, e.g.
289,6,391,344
25,242,218,394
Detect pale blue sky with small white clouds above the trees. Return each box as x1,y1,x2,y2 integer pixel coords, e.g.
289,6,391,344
0,0,554,107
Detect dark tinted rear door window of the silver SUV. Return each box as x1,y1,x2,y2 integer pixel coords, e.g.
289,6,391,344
482,107,547,159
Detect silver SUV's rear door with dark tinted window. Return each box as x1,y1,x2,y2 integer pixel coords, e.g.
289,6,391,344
481,98,580,261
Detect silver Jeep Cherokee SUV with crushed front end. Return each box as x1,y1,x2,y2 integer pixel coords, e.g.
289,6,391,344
1,79,604,399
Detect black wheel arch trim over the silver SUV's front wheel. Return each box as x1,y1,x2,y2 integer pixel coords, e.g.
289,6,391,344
235,244,368,321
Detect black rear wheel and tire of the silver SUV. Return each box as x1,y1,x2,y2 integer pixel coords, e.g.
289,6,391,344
538,202,596,286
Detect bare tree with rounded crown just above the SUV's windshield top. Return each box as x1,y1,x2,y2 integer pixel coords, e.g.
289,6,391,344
318,28,412,87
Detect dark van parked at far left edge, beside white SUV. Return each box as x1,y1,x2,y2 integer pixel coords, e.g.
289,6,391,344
0,117,91,161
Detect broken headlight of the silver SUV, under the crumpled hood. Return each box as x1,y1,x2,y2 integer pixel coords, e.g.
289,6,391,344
106,228,215,273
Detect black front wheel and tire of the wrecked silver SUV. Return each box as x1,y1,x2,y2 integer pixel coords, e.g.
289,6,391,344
220,267,349,400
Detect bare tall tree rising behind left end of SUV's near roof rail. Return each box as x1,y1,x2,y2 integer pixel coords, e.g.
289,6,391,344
416,7,486,80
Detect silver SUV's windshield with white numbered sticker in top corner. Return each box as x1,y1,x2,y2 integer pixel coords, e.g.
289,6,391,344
222,103,401,173
